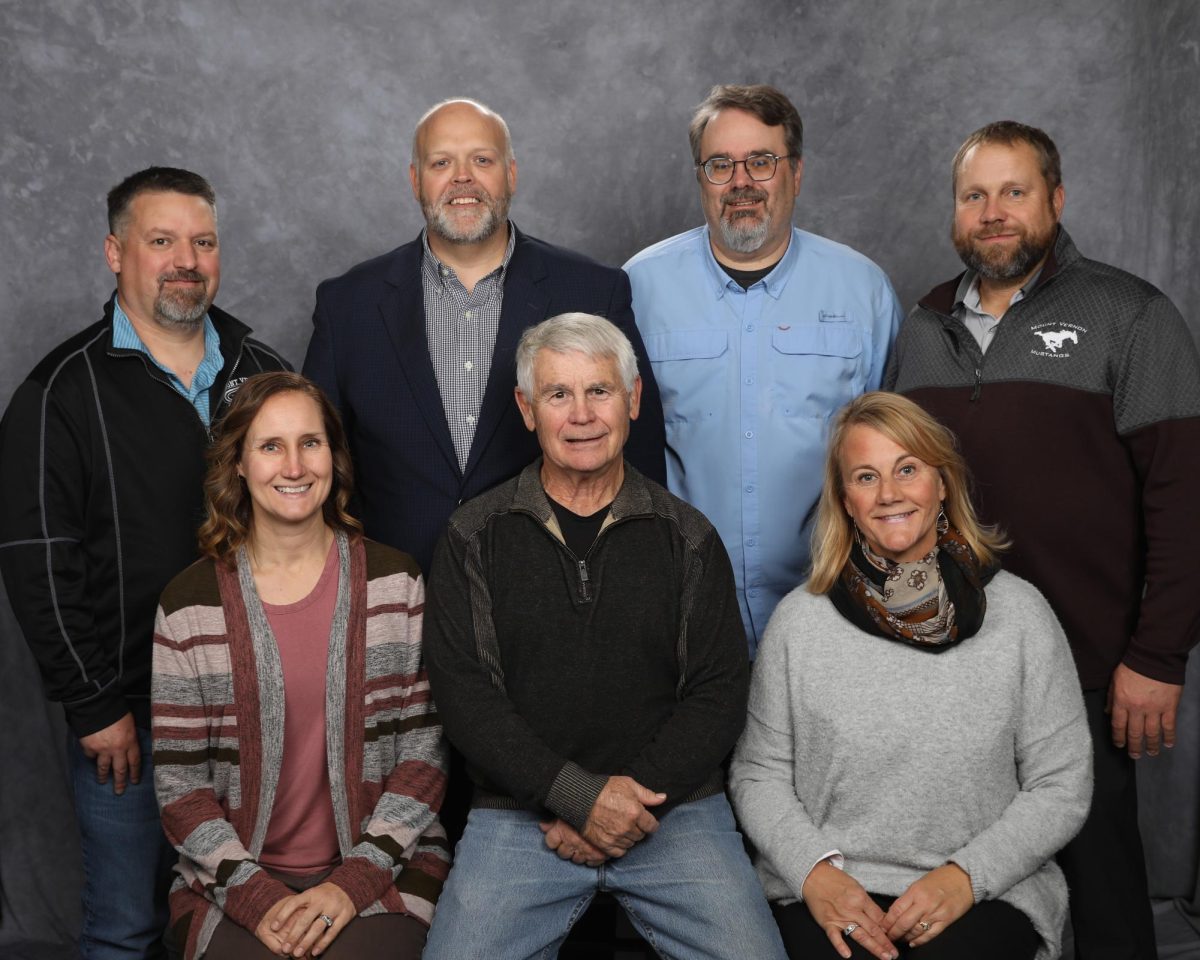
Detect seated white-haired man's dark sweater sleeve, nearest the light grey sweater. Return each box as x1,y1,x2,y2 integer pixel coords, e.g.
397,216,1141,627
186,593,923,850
626,528,750,800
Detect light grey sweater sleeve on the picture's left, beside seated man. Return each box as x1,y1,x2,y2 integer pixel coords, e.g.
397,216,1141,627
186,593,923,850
730,593,834,899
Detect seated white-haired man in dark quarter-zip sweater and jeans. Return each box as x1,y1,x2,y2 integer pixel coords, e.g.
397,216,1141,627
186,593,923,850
425,313,784,960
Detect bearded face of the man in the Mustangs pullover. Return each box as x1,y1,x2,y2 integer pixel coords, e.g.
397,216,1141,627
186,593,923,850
953,140,1064,286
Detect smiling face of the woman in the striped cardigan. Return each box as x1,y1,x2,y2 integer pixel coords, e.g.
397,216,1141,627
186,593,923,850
238,390,334,540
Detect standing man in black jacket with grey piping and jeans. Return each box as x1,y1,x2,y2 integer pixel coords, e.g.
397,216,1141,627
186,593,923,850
0,167,288,960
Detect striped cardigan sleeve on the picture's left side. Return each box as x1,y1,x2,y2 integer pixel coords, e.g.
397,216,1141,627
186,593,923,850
150,588,292,931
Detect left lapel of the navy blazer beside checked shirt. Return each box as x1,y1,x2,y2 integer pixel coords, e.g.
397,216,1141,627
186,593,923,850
379,239,460,476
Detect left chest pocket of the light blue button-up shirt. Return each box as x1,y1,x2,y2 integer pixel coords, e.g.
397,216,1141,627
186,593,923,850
642,328,731,424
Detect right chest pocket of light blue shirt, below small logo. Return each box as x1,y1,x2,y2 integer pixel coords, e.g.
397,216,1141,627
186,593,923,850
770,321,864,418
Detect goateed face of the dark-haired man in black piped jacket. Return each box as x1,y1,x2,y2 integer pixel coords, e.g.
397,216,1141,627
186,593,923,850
104,191,221,329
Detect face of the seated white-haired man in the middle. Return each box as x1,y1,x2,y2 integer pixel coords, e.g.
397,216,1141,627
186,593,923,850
516,349,642,486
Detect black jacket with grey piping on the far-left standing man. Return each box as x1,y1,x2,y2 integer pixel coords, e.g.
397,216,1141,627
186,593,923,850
0,298,289,737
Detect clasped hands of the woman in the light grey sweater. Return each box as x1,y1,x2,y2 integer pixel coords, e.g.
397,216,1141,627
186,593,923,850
803,862,974,960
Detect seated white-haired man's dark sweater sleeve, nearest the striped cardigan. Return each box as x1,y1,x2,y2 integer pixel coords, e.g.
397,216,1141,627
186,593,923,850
425,522,585,828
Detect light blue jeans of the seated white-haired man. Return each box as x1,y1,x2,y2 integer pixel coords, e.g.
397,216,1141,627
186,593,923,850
424,793,787,960
